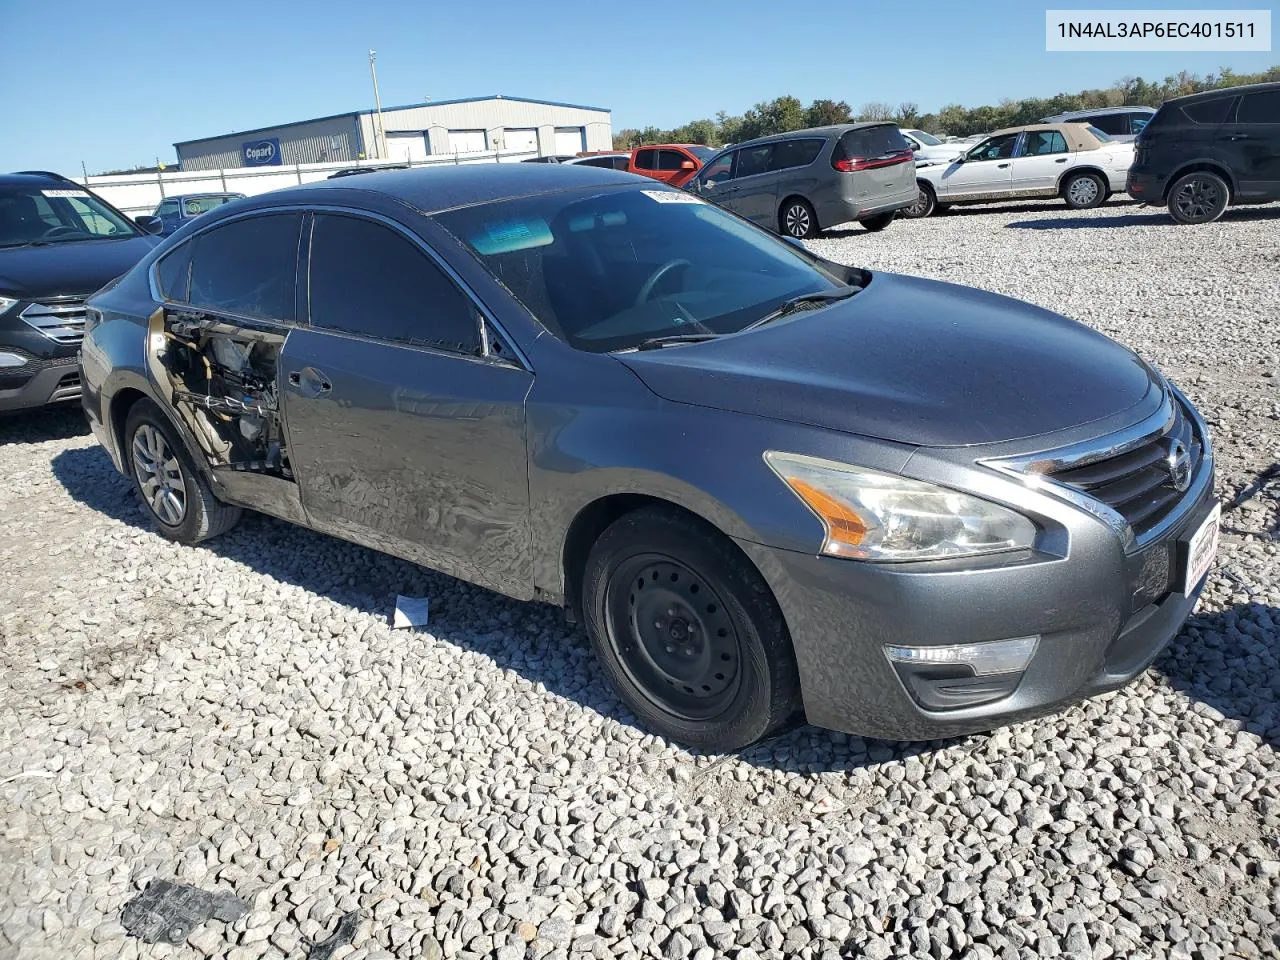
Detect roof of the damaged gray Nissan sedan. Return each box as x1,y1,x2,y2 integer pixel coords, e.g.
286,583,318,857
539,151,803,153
227,164,640,214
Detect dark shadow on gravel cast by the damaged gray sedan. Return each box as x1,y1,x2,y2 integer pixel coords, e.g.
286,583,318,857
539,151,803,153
51,447,1280,774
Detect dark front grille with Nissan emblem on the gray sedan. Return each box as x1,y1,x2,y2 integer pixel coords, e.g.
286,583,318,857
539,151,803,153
1051,401,1204,540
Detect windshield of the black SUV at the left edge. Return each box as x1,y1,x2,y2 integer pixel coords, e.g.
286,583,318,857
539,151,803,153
0,186,137,247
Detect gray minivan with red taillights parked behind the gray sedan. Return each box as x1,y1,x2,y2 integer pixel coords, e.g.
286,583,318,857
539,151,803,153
686,123,916,239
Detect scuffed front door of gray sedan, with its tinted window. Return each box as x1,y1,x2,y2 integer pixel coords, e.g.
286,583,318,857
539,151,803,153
280,214,532,598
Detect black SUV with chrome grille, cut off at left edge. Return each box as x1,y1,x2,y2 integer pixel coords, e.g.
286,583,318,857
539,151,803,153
0,172,160,412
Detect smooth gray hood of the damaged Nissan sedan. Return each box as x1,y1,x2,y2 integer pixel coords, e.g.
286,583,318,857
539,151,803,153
618,274,1158,447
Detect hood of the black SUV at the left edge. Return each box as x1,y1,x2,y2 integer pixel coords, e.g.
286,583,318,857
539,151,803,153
0,237,159,300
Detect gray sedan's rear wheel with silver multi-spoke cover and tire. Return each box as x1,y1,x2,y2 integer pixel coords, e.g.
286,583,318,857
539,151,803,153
124,399,241,544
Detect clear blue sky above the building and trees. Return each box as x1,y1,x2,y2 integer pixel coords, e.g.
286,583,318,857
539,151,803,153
0,0,1280,174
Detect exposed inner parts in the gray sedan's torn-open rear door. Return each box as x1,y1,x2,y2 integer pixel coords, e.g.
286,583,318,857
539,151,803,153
151,315,293,480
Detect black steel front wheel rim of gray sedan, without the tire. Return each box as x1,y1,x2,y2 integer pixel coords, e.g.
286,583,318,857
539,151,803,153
605,554,742,719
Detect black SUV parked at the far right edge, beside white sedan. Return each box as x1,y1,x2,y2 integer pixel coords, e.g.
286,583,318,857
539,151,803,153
1129,83,1280,223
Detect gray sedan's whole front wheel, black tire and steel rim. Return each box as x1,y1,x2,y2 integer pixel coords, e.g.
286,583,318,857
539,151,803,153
582,507,800,751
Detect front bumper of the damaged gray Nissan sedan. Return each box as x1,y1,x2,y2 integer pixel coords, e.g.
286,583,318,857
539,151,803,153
739,468,1213,740
